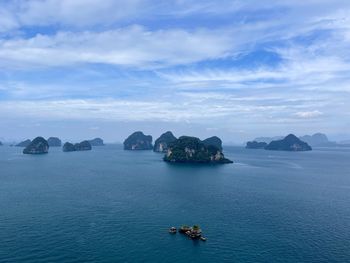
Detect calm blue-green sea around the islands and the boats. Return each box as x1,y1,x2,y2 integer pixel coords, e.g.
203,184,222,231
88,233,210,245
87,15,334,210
0,145,350,262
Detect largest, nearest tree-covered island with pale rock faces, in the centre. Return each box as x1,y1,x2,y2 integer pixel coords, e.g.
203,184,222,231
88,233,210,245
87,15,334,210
163,136,232,164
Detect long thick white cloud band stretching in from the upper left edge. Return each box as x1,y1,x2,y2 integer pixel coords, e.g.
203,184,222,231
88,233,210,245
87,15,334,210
0,26,232,67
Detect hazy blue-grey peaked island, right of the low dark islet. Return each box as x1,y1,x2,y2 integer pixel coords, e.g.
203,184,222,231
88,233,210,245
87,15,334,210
265,134,312,152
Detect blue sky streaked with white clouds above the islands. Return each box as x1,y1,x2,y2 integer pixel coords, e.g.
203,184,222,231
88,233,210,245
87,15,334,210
0,0,350,143
